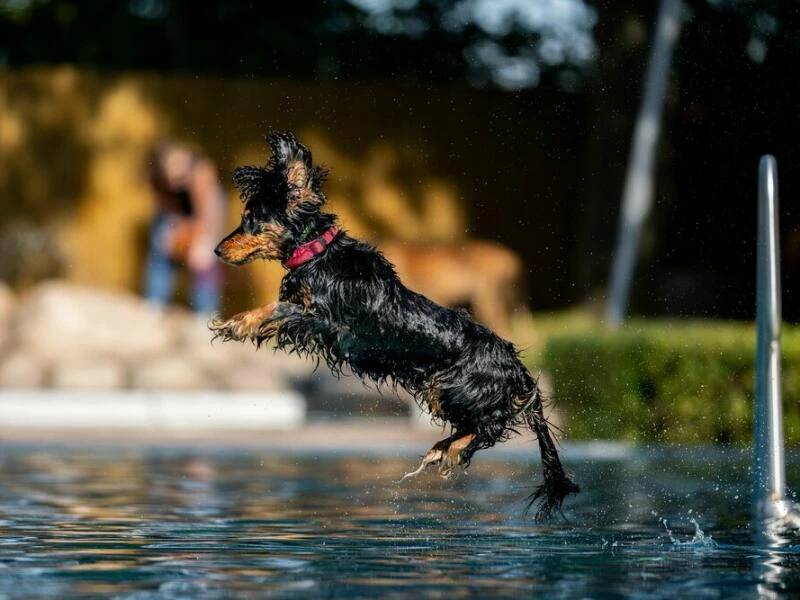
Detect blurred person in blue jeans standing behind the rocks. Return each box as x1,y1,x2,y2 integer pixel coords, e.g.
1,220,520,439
144,139,225,314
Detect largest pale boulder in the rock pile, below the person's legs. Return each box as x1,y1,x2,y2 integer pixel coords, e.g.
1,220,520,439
16,281,177,362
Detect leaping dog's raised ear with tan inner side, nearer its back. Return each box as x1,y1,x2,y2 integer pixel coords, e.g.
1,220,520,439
267,132,327,209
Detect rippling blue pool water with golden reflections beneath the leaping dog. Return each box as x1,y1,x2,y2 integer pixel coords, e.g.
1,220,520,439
0,446,800,600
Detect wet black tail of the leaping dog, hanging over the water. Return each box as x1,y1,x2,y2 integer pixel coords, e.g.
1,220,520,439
522,386,581,521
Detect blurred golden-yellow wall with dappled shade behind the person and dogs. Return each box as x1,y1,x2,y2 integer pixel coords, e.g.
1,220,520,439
0,67,581,314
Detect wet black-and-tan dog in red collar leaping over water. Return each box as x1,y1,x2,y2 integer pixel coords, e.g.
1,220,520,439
210,133,579,518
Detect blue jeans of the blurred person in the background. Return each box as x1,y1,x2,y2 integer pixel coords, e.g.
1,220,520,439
144,213,220,313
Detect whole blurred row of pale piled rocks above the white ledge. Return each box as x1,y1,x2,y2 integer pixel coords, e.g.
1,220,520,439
0,281,314,390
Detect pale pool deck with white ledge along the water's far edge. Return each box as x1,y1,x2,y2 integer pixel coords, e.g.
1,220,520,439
0,390,631,459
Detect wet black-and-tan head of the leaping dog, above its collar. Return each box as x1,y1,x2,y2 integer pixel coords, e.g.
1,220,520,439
214,133,326,265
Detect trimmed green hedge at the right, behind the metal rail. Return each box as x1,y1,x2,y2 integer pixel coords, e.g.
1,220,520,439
538,321,800,444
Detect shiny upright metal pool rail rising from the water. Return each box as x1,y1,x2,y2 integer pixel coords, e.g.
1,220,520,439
753,154,800,531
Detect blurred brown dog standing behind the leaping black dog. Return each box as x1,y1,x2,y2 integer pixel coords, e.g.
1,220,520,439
377,240,528,339
